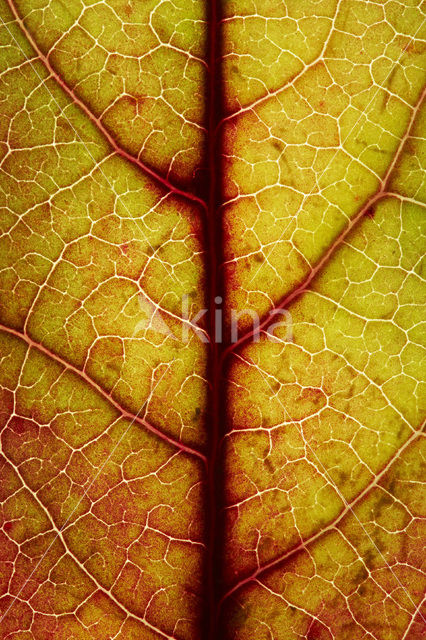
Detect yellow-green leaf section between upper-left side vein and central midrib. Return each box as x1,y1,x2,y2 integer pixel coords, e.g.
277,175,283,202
10,0,206,182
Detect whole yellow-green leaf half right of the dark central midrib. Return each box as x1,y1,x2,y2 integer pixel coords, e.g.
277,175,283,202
220,0,426,640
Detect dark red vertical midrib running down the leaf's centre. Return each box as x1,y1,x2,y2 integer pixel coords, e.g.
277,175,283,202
202,0,224,640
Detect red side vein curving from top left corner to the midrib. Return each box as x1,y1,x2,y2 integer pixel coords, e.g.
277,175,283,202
6,0,206,209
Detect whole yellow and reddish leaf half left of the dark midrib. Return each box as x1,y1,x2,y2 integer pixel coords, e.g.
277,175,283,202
0,0,206,640
